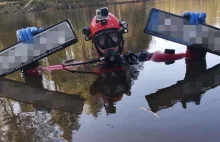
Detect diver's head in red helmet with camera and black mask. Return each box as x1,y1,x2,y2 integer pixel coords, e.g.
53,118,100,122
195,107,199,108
83,7,128,63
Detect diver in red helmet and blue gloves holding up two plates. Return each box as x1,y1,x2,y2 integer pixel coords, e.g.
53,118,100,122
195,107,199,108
16,7,206,72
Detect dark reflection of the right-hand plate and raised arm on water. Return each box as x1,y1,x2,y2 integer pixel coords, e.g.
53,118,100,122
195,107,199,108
145,59,220,112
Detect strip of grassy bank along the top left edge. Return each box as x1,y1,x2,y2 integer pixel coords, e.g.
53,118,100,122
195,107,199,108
0,0,148,14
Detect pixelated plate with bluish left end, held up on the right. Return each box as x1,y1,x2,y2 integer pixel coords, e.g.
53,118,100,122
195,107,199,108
144,8,220,55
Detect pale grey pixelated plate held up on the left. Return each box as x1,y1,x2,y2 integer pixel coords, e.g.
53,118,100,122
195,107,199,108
0,20,77,76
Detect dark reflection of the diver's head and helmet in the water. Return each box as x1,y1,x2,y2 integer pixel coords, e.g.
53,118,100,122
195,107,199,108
90,65,142,114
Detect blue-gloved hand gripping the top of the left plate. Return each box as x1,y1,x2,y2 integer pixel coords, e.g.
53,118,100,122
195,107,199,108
16,27,44,42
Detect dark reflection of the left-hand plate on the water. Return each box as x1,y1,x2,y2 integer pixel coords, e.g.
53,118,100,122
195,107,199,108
0,78,85,114
